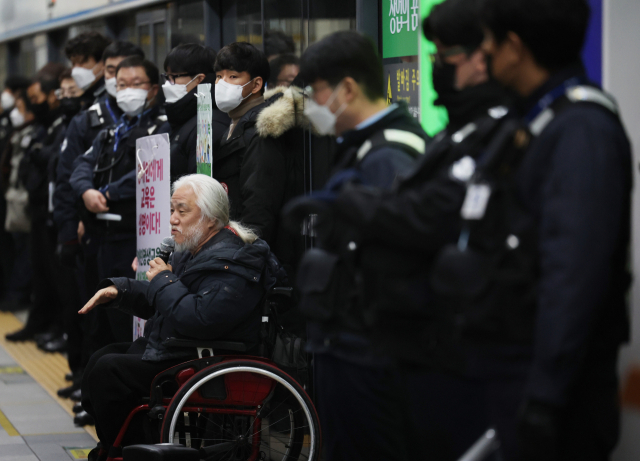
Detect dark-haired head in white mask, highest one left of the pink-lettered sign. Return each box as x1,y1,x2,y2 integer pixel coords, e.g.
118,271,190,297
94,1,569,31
64,31,111,90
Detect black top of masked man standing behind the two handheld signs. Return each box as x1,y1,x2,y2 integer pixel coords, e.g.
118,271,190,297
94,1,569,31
164,74,231,182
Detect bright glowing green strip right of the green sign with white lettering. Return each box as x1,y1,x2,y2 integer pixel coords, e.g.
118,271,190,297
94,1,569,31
418,0,449,136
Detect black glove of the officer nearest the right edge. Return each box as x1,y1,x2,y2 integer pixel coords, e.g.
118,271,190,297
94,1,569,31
518,400,559,461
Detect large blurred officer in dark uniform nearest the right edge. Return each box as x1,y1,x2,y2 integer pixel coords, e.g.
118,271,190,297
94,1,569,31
456,0,632,460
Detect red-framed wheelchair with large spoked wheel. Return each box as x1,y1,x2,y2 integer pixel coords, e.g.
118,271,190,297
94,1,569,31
107,288,322,461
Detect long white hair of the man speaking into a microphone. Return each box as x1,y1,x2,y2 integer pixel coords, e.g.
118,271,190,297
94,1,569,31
171,174,258,243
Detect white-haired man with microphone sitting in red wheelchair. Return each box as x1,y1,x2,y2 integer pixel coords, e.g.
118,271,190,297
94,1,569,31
80,175,320,460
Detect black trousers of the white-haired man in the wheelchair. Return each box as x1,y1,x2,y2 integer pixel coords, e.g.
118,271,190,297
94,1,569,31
82,338,186,447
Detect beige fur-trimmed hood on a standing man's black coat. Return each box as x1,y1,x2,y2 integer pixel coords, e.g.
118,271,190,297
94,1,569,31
256,86,315,138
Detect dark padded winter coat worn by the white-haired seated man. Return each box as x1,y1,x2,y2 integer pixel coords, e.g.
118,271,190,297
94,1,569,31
100,229,279,361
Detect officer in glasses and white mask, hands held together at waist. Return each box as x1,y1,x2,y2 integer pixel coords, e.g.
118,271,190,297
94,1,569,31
70,56,167,360
